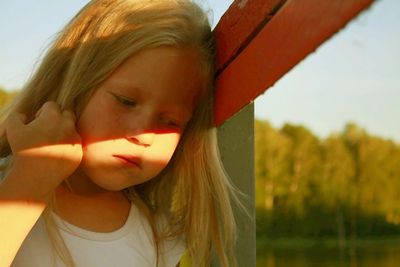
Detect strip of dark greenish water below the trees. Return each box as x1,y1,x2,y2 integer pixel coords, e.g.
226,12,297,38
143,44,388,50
257,242,400,267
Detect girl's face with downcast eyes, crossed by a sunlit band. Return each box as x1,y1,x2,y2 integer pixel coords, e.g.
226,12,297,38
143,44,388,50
77,47,201,191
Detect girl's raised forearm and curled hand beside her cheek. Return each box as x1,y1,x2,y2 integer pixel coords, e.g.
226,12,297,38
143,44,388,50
0,102,82,267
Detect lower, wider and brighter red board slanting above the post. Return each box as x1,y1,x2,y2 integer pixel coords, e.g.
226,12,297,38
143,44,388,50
215,0,373,125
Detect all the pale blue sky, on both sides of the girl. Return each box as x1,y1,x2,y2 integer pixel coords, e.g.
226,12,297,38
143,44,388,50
0,0,400,143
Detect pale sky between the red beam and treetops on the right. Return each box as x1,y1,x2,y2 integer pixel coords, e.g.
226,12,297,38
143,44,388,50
256,0,400,144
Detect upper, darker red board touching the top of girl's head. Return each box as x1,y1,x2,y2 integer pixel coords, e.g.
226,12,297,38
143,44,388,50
215,0,286,70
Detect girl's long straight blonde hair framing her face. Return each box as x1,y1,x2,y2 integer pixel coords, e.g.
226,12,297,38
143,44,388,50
0,0,236,266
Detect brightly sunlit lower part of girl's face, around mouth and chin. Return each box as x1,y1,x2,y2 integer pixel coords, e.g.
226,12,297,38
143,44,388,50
82,133,180,190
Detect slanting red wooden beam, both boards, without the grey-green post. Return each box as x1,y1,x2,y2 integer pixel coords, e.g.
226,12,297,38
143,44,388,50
215,0,373,126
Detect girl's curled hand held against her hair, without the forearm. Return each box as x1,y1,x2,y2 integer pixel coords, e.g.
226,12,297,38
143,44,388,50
6,102,82,201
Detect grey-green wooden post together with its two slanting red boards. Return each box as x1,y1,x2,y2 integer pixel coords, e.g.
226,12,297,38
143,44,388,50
214,0,373,267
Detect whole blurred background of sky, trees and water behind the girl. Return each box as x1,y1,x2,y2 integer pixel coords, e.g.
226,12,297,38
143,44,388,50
0,0,400,266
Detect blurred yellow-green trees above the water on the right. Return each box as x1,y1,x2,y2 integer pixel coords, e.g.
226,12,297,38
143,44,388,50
255,120,400,242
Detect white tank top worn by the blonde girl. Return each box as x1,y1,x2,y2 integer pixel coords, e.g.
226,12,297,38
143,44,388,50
11,204,185,267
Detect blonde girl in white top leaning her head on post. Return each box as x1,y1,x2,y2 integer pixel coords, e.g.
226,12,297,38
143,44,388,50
0,0,239,266
